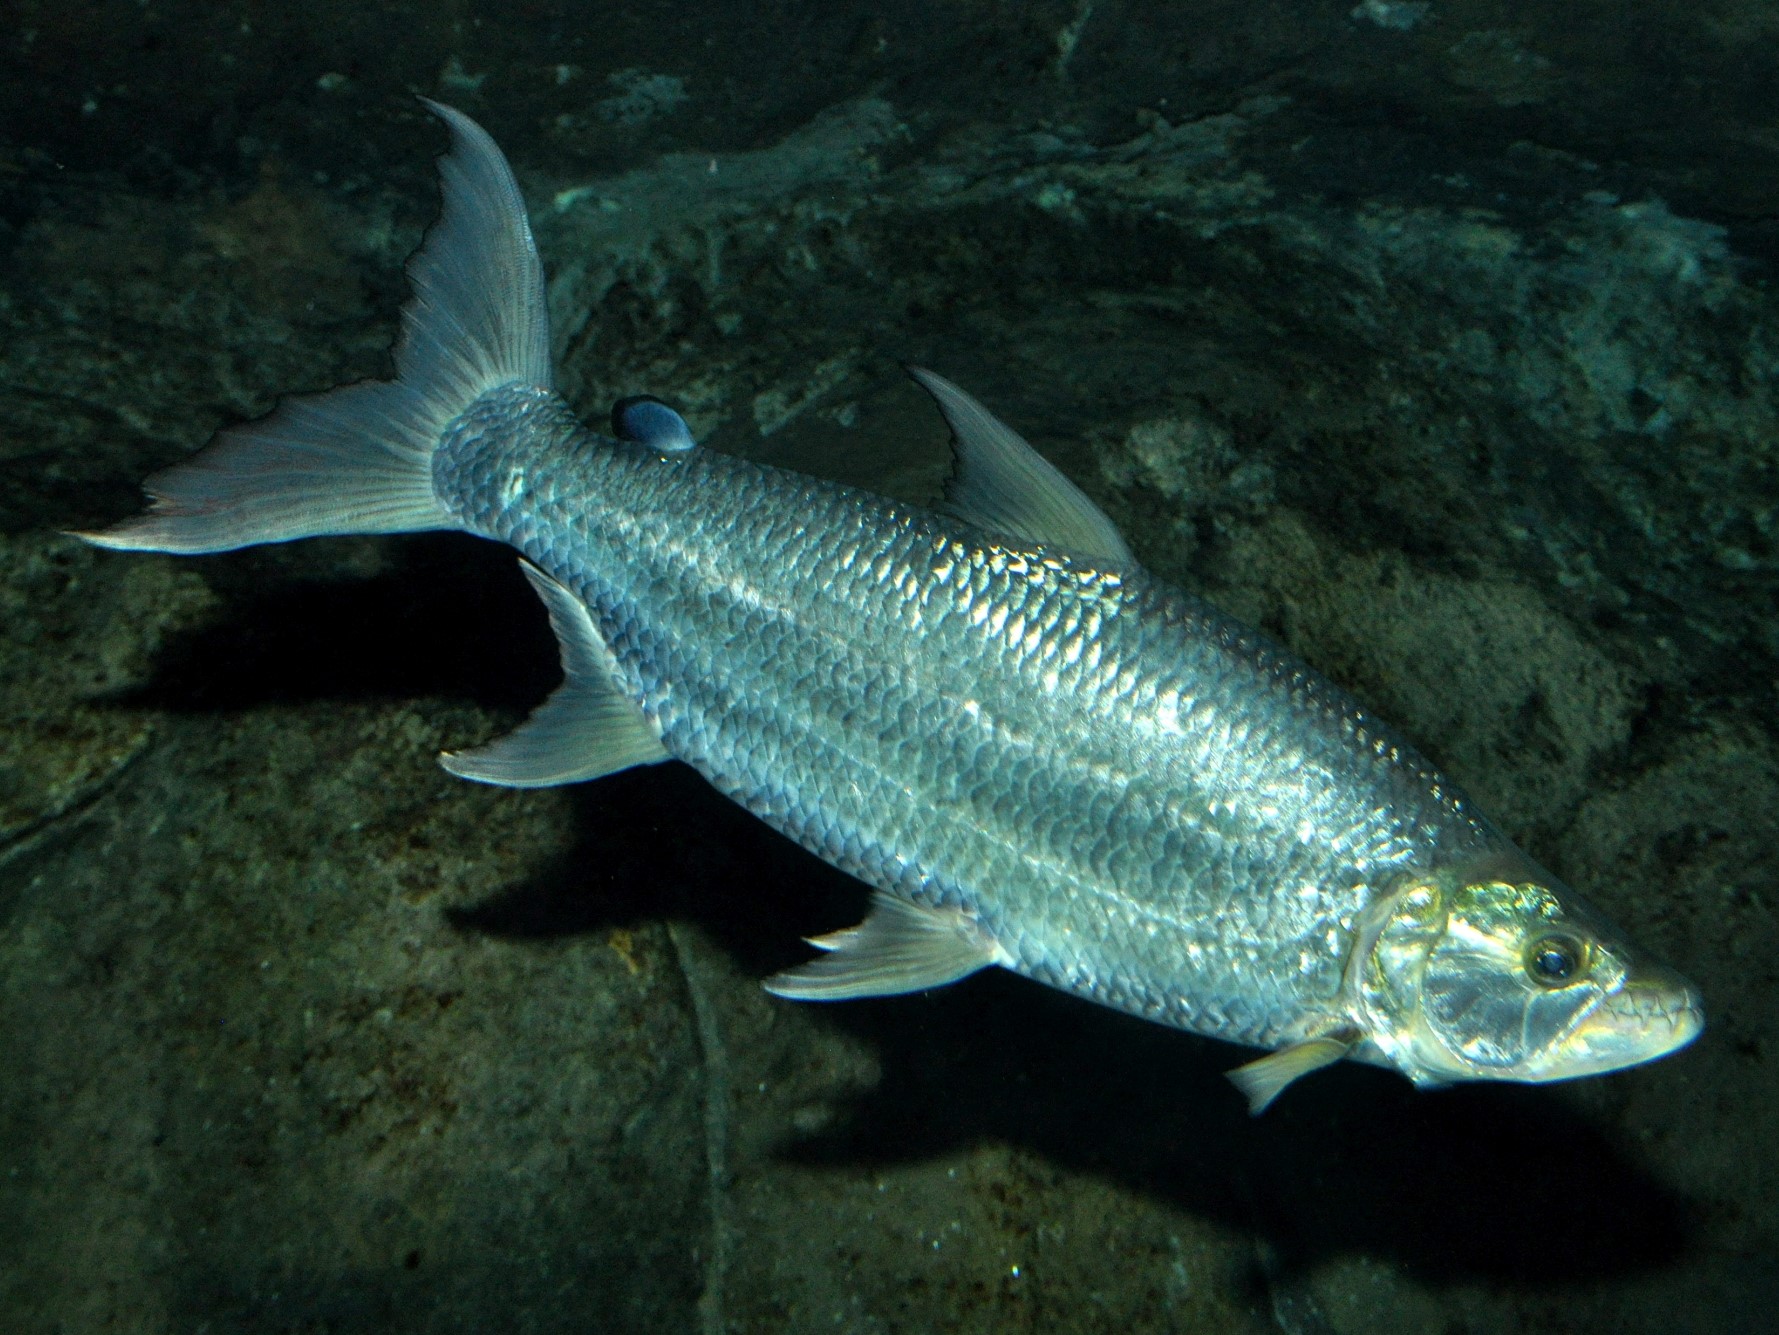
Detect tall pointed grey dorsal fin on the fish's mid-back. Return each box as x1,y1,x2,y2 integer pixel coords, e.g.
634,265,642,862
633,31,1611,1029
907,367,1137,566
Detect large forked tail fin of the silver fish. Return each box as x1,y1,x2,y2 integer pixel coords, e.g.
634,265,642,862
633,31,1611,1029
76,98,551,554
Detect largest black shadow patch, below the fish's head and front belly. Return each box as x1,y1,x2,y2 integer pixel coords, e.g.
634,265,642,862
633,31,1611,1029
790,975,1686,1283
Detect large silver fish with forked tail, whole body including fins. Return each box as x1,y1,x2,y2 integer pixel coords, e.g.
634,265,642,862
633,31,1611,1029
82,103,1703,1111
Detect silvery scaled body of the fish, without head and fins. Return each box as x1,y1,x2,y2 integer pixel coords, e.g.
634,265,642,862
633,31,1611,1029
434,390,1489,1047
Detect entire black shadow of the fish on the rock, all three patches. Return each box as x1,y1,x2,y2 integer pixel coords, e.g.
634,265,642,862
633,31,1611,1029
107,538,1688,1283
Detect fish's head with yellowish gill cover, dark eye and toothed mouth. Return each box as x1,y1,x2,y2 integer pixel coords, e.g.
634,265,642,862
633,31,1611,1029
1352,874,1704,1084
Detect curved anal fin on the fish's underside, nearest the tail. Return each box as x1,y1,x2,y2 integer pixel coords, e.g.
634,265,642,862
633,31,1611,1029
439,562,671,789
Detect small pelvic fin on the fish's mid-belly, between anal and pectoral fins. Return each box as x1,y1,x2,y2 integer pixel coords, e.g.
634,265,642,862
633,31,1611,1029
765,890,1005,1000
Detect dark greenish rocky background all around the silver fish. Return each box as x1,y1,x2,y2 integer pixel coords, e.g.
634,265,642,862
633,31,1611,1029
0,0,1779,1335
